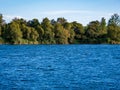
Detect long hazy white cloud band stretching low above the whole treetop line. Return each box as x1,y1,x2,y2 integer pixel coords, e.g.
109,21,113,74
3,10,117,25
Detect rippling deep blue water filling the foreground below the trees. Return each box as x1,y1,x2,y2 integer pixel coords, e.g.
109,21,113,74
0,45,120,90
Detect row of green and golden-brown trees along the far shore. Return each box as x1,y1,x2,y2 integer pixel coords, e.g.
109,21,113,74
0,14,120,44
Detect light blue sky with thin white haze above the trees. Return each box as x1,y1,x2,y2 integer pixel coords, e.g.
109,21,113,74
0,0,120,25
